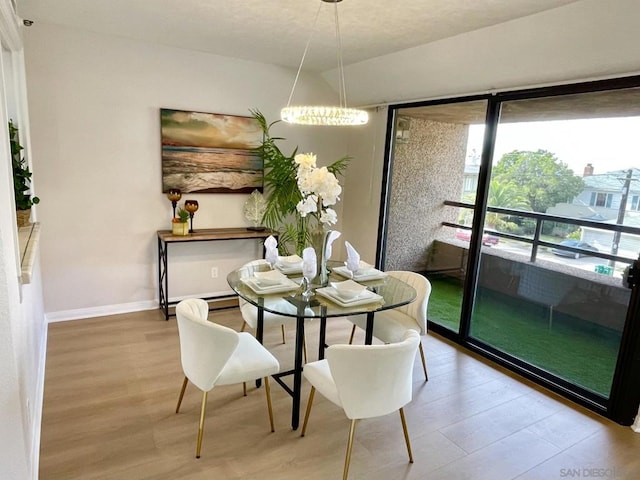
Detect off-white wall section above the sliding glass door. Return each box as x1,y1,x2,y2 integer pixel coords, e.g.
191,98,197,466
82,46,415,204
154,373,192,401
338,0,640,105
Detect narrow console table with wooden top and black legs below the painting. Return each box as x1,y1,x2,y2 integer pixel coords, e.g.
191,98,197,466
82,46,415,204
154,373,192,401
158,228,278,320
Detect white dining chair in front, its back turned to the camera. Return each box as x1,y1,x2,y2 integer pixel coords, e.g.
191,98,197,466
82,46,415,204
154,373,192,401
301,330,420,480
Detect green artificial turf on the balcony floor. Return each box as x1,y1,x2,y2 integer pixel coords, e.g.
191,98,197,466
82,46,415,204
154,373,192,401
428,278,621,397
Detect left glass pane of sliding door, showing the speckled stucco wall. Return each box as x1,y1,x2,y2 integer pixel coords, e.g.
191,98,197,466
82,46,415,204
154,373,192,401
385,100,487,332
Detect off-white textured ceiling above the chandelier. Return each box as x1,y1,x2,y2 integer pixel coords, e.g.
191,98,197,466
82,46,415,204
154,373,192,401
15,0,577,71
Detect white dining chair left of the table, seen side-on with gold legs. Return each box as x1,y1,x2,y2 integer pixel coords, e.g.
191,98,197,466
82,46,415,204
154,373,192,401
176,298,280,458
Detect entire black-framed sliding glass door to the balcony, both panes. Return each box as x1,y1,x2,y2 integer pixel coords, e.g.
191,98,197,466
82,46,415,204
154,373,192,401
380,77,640,420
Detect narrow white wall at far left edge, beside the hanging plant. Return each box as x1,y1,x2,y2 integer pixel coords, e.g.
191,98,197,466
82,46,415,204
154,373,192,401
0,0,46,480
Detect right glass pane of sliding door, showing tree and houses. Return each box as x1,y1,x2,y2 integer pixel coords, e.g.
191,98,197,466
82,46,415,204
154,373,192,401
469,89,640,399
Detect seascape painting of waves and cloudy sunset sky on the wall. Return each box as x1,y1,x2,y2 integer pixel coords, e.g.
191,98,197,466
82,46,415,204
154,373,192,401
160,108,264,193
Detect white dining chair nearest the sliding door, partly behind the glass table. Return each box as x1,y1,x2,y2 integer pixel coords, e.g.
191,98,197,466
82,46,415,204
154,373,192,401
346,271,431,382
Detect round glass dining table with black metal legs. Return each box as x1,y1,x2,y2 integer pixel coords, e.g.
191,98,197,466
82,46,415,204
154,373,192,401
227,261,416,430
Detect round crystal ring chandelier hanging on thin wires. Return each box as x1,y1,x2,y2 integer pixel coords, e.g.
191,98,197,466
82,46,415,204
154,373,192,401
280,0,369,126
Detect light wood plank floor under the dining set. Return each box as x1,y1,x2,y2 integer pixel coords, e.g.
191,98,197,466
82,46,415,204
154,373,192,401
40,308,640,480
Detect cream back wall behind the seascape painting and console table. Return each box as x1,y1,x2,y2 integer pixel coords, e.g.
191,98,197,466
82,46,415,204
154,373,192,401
25,23,346,319
